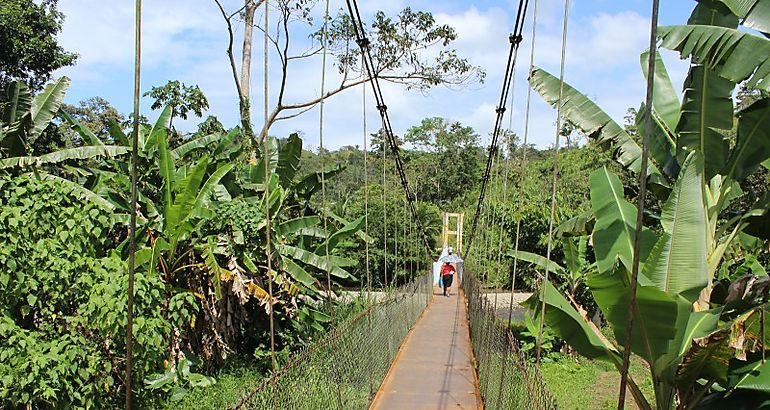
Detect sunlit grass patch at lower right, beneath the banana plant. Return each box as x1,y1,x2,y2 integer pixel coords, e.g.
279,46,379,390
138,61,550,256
541,354,654,409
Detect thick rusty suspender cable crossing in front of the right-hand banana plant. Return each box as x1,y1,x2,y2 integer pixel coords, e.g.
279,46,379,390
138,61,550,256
618,0,660,410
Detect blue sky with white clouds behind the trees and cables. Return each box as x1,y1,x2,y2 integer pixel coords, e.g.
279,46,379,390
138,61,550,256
56,0,695,148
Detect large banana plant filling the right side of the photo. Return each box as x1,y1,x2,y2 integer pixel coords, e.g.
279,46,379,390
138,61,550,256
530,1,770,409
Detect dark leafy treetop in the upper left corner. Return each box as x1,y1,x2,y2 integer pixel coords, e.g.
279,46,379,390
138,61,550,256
0,0,77,90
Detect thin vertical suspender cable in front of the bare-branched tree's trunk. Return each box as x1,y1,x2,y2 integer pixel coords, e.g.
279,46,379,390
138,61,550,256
262,0,278,380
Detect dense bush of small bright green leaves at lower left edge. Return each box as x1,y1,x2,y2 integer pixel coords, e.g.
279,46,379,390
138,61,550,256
0,177,196,407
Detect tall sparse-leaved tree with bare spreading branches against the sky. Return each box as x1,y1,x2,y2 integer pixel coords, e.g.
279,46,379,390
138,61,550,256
214,0,485,141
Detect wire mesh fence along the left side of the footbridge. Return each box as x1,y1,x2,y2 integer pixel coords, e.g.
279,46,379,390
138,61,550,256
228,275,433,410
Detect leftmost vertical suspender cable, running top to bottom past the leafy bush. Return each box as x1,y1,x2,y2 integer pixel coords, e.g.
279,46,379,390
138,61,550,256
126,0,142,410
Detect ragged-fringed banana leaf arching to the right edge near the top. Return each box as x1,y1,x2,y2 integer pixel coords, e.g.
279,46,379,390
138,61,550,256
658,25,770,91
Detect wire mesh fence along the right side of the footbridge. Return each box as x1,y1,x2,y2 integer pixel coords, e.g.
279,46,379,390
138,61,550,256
463,274,556,410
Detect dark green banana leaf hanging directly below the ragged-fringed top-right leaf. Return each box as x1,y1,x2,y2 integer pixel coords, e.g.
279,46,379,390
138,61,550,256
677,65,735,179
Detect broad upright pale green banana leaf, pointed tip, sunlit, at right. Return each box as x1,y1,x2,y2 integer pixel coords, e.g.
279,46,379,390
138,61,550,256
644,152,709,303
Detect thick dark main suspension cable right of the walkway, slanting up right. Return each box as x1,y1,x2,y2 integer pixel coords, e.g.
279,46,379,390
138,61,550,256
466,0,529,255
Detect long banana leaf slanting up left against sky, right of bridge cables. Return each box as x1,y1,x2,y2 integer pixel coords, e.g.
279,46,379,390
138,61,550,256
529,67,663,182
